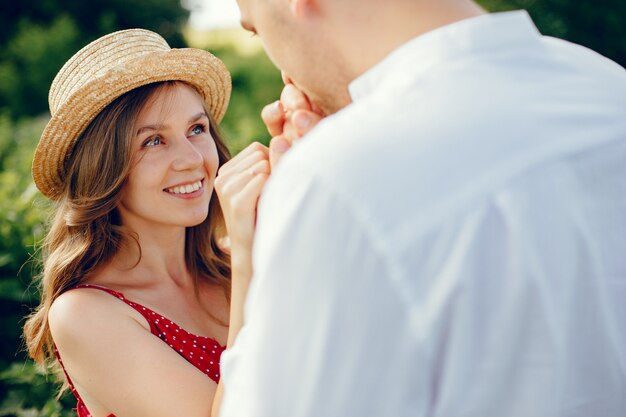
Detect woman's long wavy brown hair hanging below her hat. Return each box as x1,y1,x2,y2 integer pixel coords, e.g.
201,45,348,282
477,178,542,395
24,81,230,384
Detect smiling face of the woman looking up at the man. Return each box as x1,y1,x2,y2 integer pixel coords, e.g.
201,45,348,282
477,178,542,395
118,83,219,231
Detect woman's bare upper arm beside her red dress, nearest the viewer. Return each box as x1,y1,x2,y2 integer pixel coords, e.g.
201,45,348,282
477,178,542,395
48,288,217,417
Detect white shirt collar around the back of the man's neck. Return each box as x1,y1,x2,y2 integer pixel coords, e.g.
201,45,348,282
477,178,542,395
348,10,541,101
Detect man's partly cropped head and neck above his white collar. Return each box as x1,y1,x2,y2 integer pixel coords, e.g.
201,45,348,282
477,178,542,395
237,0,482,114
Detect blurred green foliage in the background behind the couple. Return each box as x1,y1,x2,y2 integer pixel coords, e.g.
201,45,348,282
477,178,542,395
0,0,626,417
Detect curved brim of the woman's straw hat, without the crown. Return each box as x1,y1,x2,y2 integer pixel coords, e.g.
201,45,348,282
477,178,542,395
32,48,231,200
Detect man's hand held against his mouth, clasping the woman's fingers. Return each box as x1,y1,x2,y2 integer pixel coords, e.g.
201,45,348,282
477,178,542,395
261,74,324,168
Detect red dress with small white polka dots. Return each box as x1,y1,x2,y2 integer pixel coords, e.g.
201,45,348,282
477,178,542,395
55,285,225,417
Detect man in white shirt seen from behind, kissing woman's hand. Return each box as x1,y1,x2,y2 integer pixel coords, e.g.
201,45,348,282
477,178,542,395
221,0,626,417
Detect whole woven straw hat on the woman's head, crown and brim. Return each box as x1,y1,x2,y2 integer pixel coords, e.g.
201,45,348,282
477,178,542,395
32,29,231,200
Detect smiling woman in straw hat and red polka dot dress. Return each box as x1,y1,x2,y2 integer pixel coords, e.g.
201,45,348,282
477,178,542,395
24,29,269,417
